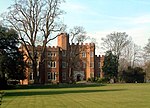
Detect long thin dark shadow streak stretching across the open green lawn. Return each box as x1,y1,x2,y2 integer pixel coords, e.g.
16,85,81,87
5,89,126,97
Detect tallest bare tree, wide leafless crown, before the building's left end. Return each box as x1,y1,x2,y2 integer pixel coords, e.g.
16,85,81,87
2,0,64,83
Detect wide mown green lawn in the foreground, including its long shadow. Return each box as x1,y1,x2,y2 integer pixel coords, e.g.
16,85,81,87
0,84,150,108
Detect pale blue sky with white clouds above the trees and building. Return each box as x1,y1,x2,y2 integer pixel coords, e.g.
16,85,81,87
0,0,150,54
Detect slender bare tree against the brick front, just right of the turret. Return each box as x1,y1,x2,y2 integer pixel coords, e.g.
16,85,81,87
67,26,88,81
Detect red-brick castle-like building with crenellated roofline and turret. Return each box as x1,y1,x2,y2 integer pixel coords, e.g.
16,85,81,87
22,33,104,84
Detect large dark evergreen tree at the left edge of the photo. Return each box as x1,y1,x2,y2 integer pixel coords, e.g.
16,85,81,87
0,26,25,87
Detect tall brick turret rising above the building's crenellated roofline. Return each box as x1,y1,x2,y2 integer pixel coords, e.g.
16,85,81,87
57,33,69,50
